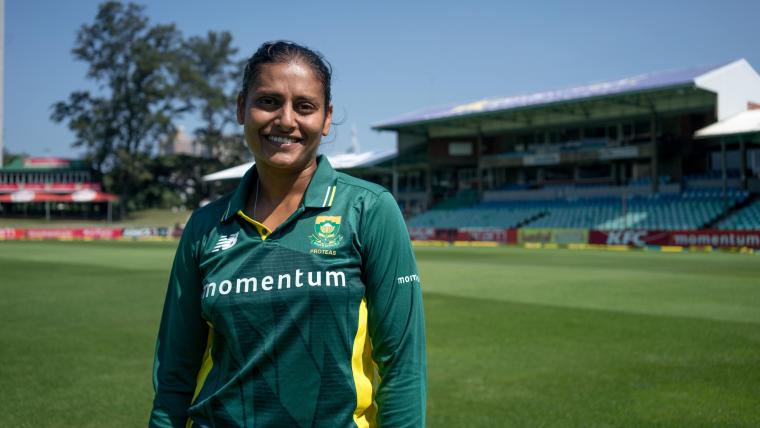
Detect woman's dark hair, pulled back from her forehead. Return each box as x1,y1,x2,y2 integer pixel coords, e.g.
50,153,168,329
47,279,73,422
241,40,332,108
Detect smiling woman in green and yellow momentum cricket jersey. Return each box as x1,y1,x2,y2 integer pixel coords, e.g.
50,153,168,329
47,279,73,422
150,41,426,427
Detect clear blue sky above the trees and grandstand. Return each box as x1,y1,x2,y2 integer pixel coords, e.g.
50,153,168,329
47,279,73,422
4,0,760,157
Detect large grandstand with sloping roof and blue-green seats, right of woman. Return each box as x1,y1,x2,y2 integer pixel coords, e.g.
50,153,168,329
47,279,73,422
374,59,760,244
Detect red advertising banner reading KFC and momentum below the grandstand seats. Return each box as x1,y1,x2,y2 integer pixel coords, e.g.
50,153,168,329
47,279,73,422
588,230,760,248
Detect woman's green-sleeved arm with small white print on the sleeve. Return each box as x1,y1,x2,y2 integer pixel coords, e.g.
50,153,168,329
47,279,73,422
361,192,427,427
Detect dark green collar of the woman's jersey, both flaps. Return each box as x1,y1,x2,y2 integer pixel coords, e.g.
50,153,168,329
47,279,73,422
221,155,337,221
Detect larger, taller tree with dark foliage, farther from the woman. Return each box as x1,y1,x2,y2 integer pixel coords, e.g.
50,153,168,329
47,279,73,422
51,1,185,213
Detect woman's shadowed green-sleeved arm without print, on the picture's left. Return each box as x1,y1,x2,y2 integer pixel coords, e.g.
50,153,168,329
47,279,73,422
148,218,208,428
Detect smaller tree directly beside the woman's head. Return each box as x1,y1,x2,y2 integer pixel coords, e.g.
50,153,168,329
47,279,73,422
179,31,250,166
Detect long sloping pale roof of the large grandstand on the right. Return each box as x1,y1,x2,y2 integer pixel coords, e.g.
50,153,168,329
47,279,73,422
373,59,758,130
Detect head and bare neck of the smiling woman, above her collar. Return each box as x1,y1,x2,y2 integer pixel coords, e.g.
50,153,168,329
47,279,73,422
237,42,332,230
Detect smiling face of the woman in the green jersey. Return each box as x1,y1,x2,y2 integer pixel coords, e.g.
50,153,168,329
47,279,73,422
237,60,332,171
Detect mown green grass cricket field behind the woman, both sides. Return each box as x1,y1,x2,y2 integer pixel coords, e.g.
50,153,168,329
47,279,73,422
0,242,760,427
